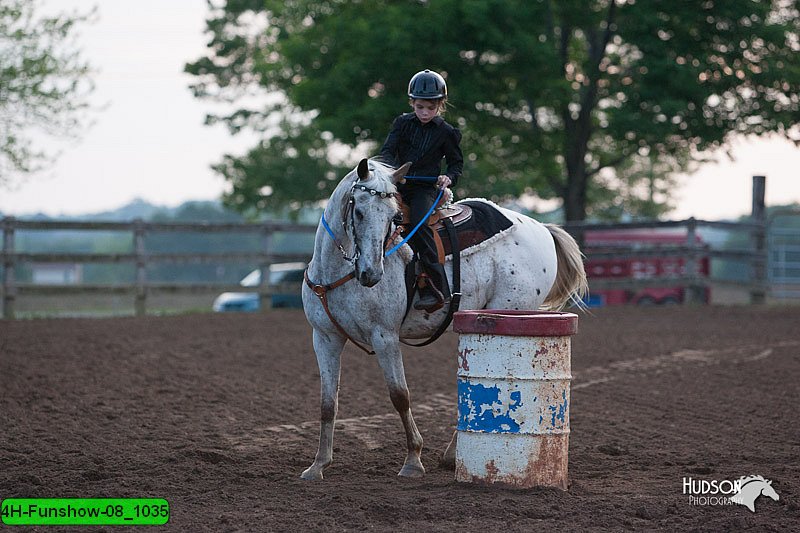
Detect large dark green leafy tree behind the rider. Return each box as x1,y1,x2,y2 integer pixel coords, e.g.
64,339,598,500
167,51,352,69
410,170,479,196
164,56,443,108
186,0,800,220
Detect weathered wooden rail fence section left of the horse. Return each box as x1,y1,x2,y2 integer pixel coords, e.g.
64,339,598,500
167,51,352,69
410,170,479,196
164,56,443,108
0,217,316,319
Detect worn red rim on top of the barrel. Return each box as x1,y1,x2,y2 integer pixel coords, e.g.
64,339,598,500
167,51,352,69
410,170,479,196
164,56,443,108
453,309,578,337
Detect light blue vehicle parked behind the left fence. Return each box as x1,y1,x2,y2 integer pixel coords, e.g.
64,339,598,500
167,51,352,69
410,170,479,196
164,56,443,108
211,263,306,312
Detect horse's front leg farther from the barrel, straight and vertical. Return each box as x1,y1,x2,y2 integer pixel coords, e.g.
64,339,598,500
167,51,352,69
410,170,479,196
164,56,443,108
300,329,345,480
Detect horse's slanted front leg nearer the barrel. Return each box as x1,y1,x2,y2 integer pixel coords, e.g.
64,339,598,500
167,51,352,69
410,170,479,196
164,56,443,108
372,333,425,477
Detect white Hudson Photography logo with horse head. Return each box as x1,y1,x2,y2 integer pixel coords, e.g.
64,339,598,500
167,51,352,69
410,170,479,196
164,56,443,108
683,476,780,513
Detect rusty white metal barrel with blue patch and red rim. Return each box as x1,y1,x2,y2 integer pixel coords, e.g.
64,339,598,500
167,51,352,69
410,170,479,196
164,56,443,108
453,309,578,490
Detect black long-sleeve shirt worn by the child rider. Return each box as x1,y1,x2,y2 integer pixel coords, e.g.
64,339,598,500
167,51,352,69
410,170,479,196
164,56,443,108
380,113,464,187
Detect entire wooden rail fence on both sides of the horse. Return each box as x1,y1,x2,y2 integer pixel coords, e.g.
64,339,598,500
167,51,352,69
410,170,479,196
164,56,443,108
0,194,768,318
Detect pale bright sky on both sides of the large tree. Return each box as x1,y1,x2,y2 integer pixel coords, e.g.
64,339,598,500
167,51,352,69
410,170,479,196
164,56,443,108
0,0,800,220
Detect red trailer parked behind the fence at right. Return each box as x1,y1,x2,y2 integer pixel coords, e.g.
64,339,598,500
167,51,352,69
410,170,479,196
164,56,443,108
584,230,711,306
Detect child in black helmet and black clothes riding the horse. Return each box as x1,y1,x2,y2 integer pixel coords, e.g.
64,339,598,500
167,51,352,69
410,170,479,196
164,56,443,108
380,70,464,313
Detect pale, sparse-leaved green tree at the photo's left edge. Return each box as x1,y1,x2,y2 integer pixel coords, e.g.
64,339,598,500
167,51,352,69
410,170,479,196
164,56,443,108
0,0,94,184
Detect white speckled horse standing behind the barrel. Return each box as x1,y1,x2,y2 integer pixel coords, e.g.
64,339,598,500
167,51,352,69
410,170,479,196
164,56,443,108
301,159,587,479
